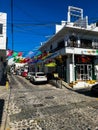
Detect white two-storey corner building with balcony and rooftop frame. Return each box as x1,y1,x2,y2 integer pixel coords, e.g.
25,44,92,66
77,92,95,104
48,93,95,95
35,6,98,86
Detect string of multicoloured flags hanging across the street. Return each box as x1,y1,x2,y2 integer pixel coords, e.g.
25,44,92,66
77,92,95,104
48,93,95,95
7,49,56,64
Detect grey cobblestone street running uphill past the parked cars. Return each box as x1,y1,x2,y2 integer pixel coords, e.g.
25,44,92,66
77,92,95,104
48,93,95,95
1,75,98,130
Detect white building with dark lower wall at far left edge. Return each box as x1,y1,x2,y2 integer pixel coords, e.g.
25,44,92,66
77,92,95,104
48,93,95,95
0,13,7,85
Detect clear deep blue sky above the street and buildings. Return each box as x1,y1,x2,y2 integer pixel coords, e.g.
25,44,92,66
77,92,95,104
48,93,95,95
0,0,98,53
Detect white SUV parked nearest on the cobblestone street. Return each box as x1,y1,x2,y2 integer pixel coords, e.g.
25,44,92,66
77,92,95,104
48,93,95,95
30,72,47,83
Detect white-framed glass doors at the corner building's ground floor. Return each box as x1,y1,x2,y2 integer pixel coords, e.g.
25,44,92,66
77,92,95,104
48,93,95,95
76,64,92,80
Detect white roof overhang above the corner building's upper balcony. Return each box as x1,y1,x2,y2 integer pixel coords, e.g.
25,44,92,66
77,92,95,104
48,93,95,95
39,26,98,50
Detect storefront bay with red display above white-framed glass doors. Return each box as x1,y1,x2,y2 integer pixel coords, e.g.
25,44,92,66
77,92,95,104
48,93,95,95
75,55,95,81
